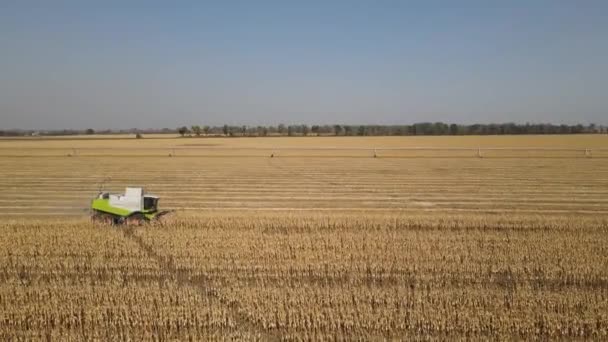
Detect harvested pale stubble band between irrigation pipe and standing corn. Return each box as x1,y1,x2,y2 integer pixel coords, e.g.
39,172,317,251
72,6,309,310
0,157,608,218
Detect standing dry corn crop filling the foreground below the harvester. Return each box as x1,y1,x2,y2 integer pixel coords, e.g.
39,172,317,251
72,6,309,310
0,214,608,340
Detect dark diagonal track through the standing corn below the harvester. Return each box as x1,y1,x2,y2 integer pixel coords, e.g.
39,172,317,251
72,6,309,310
123,227,281,341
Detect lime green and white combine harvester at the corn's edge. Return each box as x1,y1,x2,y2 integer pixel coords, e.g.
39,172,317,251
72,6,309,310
91,187,170,225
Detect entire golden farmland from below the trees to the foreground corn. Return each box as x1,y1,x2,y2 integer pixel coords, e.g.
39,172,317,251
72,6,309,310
0,135,608,340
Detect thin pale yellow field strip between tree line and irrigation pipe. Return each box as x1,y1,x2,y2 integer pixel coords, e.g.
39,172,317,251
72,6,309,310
0,134,608,148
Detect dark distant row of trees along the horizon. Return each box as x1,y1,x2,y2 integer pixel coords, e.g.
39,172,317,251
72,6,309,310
0,122,608,137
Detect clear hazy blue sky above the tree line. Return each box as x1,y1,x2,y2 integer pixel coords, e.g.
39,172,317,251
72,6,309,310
0,0,608,129
